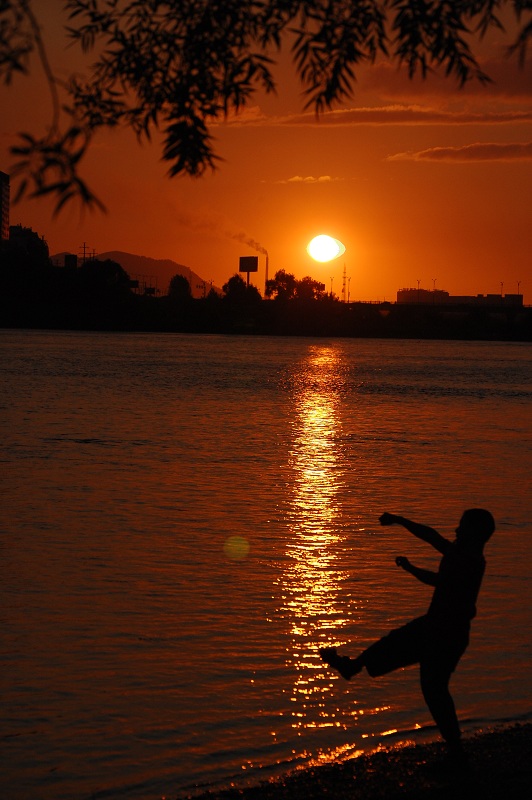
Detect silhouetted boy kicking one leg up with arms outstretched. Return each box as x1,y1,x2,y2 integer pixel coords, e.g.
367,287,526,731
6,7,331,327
320,508,495,759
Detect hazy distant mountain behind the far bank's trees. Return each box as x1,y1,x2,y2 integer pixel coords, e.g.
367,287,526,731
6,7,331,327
51,250,221,297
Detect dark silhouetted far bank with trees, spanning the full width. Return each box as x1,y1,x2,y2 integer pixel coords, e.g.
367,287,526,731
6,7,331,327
0,226,532,341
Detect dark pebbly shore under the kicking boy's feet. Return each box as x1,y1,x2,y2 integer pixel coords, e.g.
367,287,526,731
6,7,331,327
186,723,532,800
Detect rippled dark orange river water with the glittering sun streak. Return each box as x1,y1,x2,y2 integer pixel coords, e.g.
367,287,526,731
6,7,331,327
0,331,532,800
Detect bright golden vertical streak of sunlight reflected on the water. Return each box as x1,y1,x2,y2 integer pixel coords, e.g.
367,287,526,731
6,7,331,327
279,346,358,729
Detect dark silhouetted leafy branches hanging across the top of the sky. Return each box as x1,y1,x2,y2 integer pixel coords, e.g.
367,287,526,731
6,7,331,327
0,0,532,210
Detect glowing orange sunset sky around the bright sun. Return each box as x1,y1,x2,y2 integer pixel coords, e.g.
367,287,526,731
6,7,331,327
0,2,532,304
